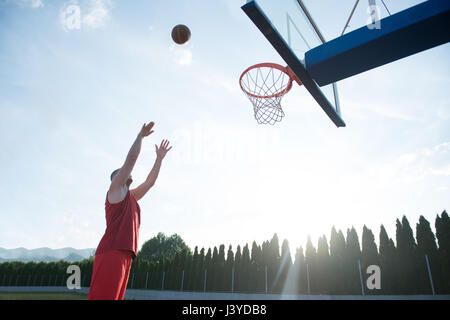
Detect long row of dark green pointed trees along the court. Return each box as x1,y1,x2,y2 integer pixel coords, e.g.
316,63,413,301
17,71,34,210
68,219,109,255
0,211,450,294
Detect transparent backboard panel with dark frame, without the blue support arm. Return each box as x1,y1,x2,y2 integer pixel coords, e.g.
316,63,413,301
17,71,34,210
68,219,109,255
242,0,345,127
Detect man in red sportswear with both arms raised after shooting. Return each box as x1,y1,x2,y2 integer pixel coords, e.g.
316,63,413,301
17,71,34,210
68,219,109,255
88,122,172,300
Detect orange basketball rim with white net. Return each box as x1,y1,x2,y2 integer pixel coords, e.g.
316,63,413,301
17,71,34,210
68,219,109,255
239,63,302,124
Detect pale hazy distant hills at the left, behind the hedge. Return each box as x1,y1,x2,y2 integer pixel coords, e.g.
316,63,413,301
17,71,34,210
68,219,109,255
0,248,95,262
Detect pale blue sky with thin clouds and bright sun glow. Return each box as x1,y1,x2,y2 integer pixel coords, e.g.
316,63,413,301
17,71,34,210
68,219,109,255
0,0,450,253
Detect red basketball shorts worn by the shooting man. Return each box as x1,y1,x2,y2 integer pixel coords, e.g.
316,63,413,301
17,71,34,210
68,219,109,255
88,250,133,300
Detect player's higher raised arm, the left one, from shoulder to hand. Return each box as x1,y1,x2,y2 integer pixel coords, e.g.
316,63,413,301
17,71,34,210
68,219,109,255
109,122,155,190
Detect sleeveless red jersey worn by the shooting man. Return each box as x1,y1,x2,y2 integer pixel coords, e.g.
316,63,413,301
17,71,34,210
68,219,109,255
95,190,141,258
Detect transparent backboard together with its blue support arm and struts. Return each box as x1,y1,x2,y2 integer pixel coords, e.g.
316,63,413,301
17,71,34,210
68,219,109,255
241,0,450,127
